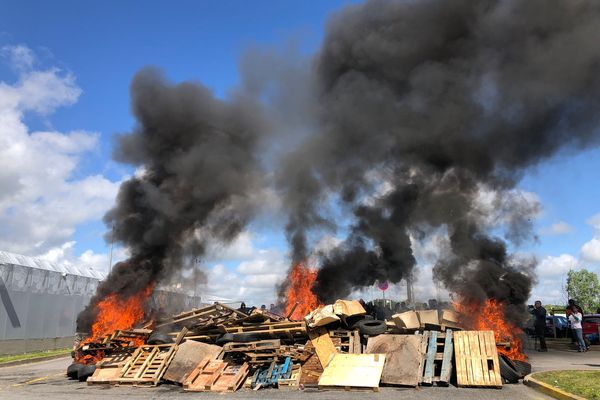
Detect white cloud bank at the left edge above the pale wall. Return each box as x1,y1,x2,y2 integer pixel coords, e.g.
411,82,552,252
0,46,119,260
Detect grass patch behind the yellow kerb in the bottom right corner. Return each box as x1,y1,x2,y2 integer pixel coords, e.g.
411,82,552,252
533,371,600,400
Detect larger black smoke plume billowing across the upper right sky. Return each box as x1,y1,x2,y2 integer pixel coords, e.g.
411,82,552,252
278,0,600,322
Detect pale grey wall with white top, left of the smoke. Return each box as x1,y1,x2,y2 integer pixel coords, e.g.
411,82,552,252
0,251,105,354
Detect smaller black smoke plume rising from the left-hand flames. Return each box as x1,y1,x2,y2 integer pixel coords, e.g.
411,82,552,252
78,69,265,332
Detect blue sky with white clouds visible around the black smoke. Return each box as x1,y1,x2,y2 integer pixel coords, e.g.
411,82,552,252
0,0,600,302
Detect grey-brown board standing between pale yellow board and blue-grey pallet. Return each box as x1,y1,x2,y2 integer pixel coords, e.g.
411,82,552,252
367,335,423,387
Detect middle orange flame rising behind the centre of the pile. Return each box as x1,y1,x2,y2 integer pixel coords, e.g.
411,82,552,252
285,262,319,321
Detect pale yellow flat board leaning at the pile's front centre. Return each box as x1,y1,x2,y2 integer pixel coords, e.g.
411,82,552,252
319,354,385,389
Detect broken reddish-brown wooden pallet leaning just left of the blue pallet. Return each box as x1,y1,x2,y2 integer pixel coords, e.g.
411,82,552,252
183,356,249,392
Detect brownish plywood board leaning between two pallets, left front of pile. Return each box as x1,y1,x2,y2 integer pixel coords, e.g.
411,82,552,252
164,340,221,383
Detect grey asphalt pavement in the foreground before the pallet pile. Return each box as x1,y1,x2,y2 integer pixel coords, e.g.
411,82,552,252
0,358,549,400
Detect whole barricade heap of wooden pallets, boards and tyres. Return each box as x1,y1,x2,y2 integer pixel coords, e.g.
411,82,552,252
67,299,531,392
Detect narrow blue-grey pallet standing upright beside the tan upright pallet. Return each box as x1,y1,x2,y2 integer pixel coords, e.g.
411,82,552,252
419,330,454,386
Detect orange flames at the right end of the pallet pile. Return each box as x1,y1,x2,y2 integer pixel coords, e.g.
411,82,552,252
454,299,527,361
